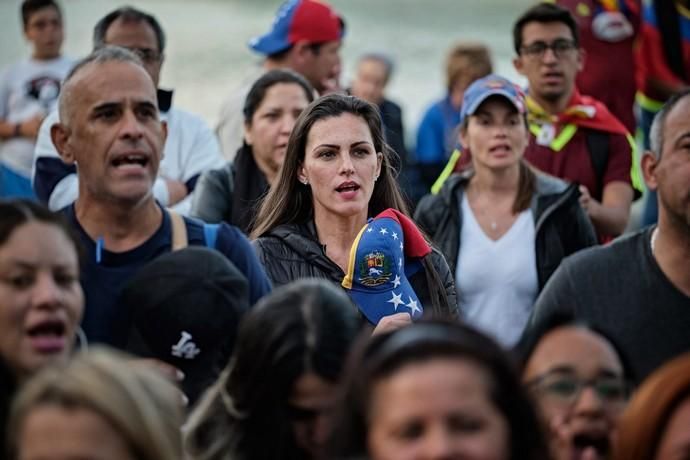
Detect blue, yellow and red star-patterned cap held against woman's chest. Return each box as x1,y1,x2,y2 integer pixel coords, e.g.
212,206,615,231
342,209,431,325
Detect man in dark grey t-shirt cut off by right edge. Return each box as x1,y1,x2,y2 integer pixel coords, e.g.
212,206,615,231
524,90,690,382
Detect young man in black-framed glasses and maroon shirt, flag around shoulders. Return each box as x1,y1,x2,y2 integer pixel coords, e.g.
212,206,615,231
513,3,642,241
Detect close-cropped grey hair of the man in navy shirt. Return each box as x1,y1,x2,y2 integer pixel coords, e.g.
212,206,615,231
58,46,153,126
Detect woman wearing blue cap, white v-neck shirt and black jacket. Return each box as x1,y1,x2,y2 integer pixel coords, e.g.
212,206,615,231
415,75,596,346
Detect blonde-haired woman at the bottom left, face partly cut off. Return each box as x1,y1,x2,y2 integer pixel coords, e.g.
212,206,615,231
9,349,183,460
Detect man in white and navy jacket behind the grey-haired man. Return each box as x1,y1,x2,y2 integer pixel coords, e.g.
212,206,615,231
33,7,224,215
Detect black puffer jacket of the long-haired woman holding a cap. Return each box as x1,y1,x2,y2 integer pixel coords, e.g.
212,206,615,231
252,222,457,317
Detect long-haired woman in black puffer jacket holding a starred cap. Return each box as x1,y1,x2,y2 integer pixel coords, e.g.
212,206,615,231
252,94,456,330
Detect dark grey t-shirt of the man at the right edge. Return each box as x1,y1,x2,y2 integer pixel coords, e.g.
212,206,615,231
525,228,690,382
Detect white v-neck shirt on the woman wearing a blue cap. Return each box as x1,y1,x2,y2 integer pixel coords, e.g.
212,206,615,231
455,195,539,347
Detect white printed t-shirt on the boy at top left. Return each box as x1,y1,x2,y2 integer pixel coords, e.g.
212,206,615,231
0,56,74,178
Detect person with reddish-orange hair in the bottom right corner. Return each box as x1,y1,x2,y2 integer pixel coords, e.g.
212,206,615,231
613,353,690,460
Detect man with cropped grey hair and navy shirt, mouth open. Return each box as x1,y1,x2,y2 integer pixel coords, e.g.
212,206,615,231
50,46,270,346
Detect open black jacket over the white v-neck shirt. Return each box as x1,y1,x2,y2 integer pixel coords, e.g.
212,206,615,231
415,171,597,292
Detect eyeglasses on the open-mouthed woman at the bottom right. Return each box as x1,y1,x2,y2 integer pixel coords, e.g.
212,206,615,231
527,373,629,407
